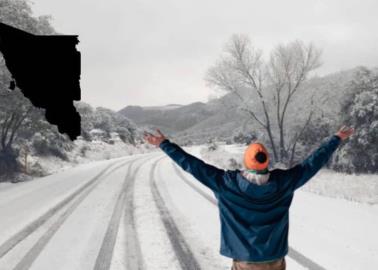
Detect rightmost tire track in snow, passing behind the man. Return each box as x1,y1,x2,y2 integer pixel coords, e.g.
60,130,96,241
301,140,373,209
172,162,326,270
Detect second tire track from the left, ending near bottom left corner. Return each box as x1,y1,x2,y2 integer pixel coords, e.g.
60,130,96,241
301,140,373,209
13,160,134,270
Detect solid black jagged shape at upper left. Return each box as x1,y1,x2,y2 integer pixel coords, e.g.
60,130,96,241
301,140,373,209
0,23,81,140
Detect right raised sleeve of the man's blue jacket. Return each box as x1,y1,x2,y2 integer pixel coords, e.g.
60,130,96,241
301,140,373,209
288,135,341,190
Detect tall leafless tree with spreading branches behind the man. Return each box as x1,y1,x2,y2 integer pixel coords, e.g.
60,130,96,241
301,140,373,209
205,35,321,165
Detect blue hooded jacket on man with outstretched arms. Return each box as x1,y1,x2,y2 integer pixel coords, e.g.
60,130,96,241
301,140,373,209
159,135,341,262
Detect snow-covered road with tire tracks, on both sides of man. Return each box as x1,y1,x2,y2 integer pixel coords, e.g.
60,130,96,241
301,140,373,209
0,152,378,270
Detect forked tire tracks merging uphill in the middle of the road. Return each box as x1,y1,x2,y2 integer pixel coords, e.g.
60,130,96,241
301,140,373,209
94,157,151,270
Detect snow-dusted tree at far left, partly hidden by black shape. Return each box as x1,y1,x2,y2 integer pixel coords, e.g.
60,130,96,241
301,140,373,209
0,0,54,176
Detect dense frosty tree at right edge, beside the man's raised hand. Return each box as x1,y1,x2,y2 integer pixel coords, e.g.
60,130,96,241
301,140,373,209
333,68,378,173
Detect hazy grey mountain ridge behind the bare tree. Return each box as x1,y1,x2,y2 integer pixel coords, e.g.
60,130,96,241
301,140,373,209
119,69,356,143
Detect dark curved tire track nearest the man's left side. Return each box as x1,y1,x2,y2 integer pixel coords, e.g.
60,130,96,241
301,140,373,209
150,157,201,270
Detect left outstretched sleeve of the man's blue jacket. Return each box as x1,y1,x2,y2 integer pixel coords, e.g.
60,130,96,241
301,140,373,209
159,139,225,192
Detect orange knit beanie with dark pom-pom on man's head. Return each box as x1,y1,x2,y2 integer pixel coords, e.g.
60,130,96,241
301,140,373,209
244,143,269,171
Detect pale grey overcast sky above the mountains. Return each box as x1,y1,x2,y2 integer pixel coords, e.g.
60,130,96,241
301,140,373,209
32,0,378,110
